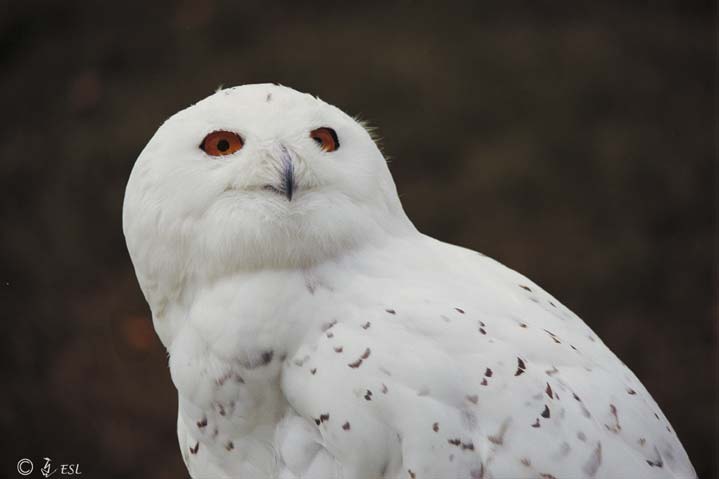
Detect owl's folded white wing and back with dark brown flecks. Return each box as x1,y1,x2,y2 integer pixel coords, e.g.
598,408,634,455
277,245,696,479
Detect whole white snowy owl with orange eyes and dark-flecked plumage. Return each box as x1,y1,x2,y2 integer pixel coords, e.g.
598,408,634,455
123,84,696,479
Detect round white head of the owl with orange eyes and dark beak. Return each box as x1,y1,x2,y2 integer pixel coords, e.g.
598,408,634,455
123,84,409,298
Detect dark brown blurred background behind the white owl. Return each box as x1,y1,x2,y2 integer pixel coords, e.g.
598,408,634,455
0,0,717,479
